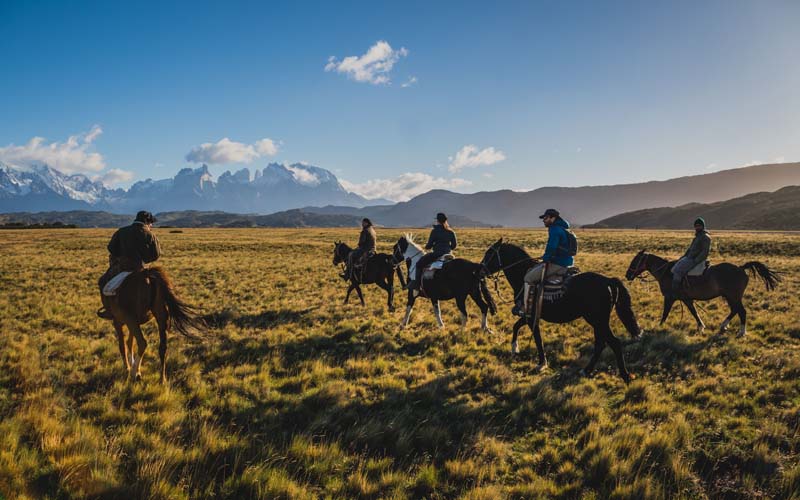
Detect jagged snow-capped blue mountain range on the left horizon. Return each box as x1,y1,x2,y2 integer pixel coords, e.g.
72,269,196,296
0,163,390,214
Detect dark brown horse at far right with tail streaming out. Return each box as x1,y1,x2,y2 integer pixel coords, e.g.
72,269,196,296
625,250,782,337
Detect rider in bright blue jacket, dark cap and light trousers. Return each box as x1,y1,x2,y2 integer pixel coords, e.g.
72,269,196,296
513,208,575,315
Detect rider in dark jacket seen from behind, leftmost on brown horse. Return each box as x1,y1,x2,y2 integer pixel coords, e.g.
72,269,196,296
97,210,161,319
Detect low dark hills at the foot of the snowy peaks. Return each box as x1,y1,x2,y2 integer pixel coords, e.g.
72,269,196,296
0,209,360,228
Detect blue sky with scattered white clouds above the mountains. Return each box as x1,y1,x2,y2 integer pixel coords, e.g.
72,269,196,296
0,0,800,199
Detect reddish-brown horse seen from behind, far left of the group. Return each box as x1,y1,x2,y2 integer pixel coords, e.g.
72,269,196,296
104,267,205,384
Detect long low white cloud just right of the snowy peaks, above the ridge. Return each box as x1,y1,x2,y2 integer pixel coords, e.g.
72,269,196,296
340,172,472,201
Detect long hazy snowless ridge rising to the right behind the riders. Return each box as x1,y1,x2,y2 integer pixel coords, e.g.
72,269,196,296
316,163,800,227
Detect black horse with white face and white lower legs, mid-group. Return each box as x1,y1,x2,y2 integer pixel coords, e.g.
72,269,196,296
393,234,497,333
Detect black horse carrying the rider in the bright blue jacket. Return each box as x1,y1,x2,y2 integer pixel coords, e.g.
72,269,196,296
480,238,641,383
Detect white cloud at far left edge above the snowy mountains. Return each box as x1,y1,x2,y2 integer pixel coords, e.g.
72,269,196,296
0,125,106,174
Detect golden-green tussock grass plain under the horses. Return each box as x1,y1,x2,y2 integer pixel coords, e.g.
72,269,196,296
0,229,800,499
